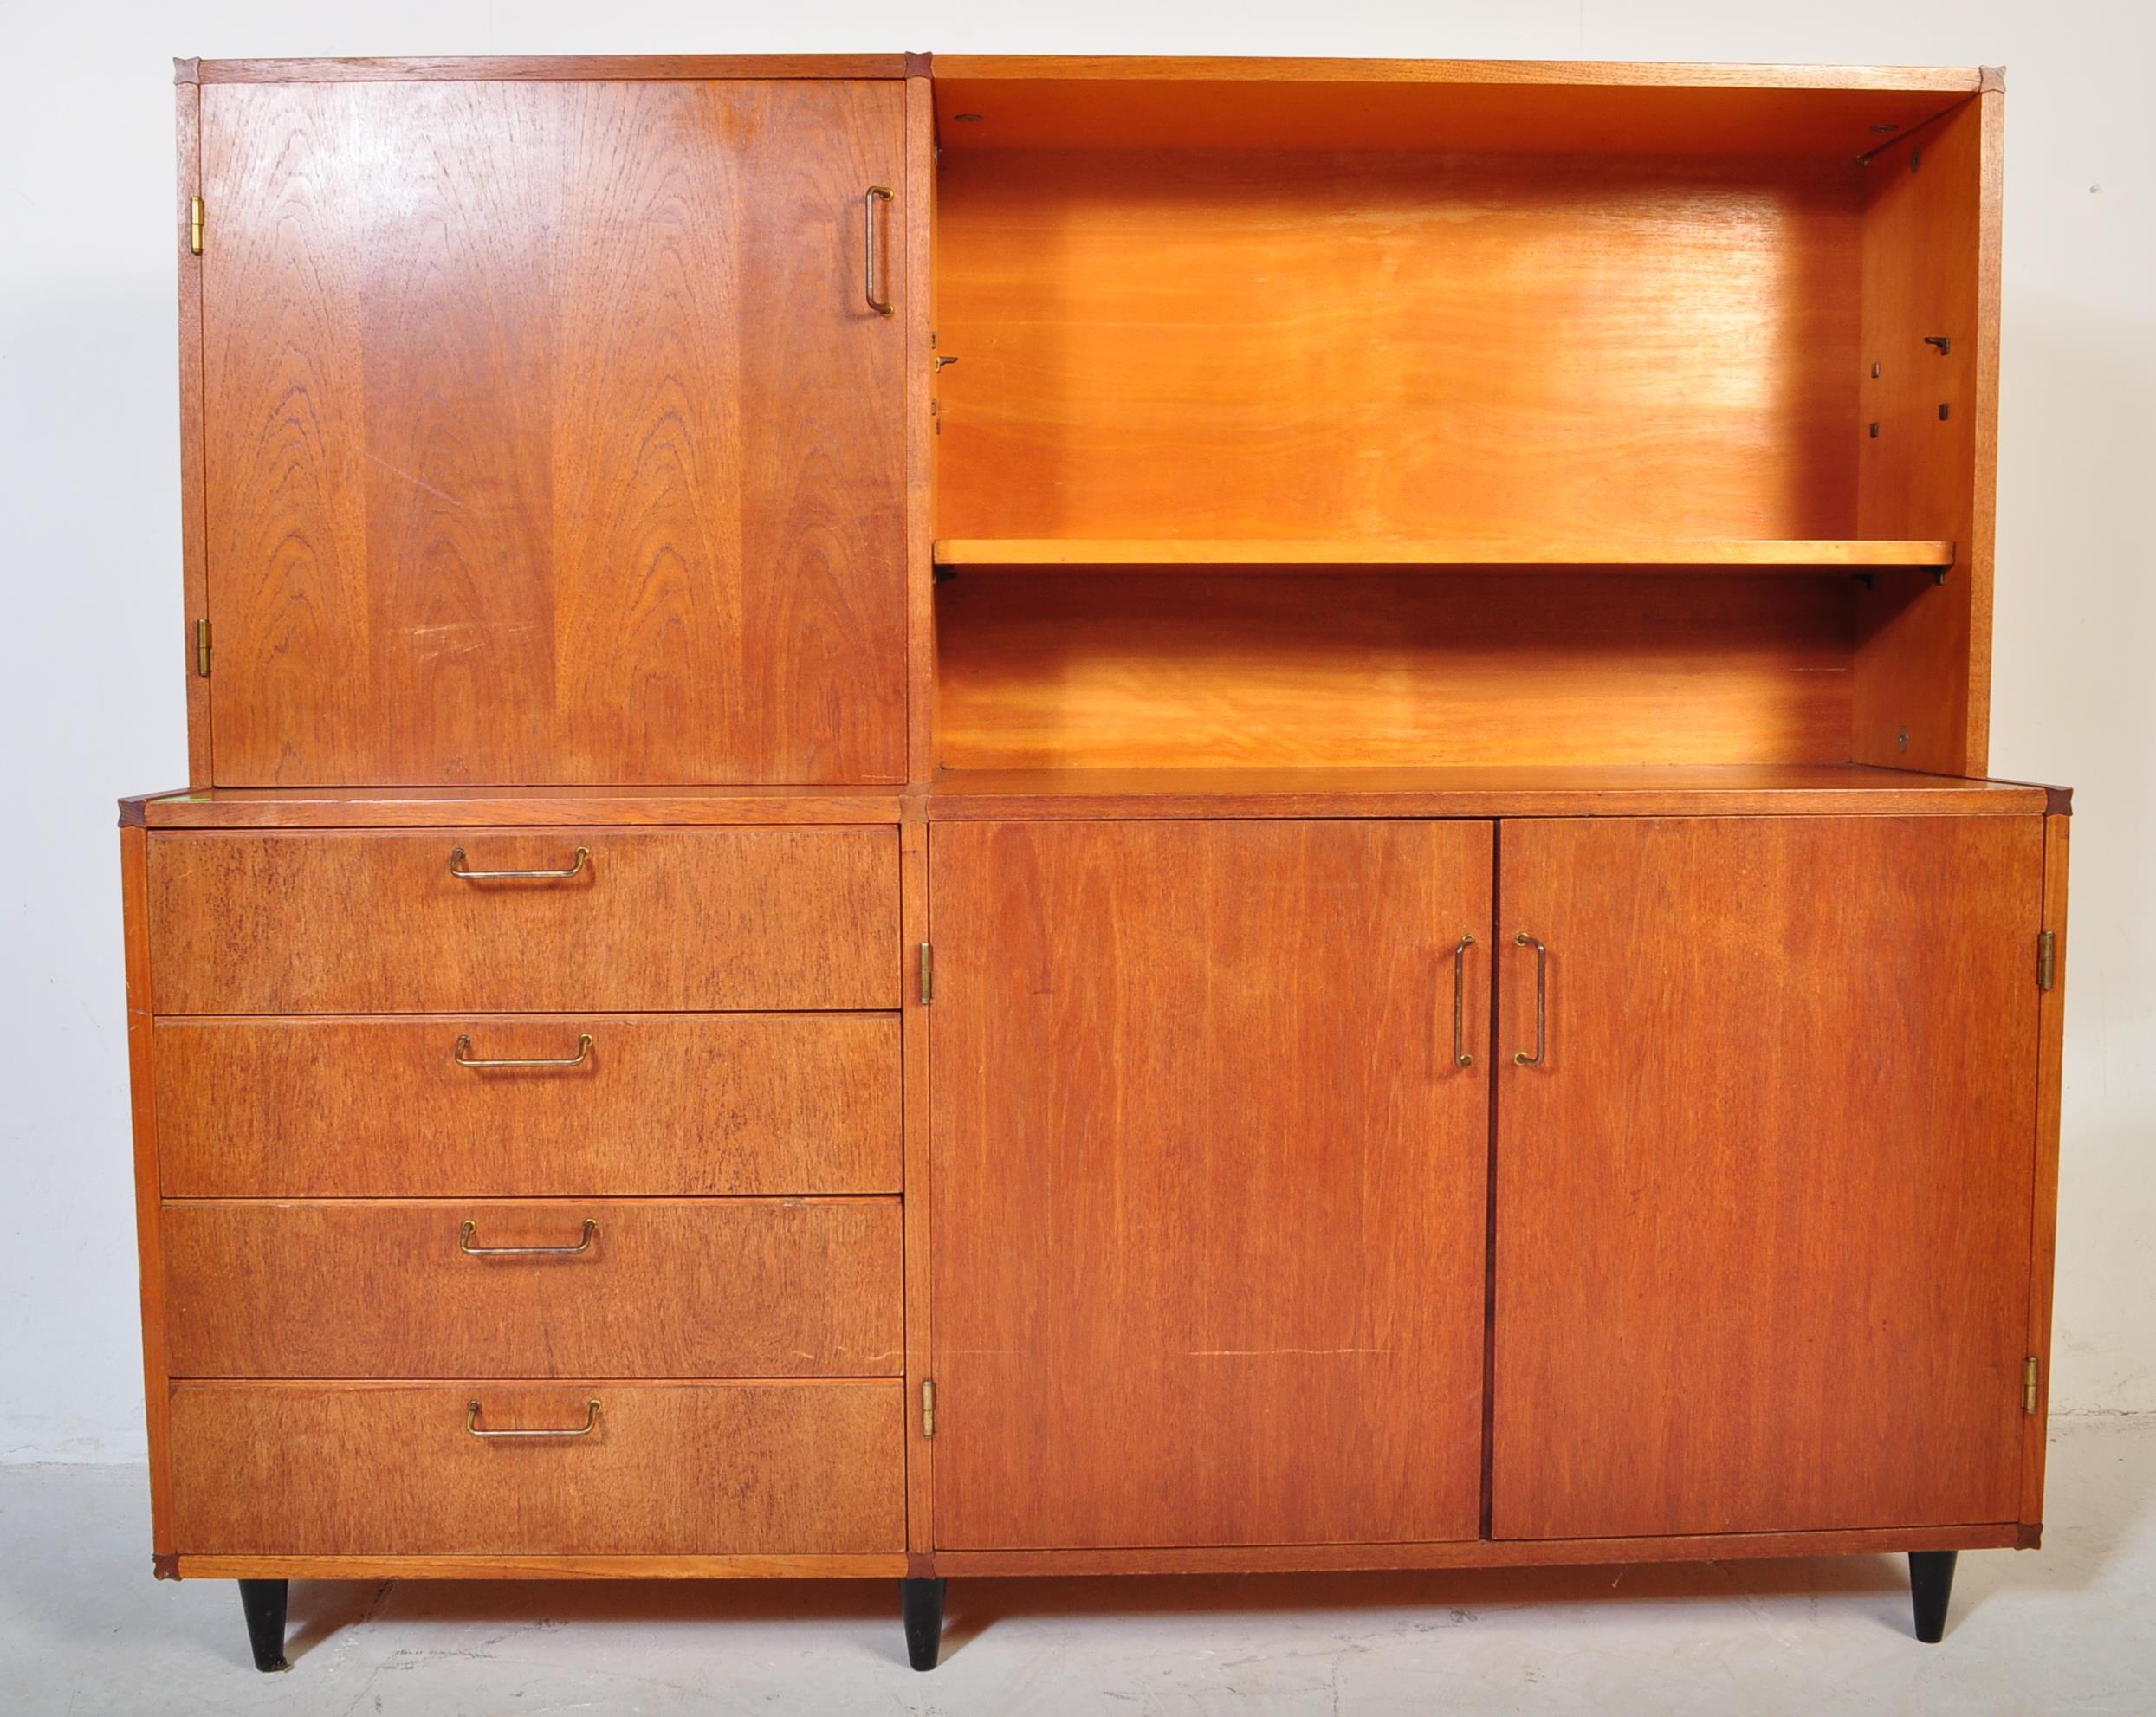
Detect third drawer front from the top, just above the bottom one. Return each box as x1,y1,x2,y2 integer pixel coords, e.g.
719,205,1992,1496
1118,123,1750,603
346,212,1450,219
164,1199,905,1378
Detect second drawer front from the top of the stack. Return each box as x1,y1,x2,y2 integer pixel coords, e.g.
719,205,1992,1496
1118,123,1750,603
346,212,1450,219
153,1014,899,1197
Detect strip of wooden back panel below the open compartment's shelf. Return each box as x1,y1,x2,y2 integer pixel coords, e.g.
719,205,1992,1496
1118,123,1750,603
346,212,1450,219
940,573,1852,770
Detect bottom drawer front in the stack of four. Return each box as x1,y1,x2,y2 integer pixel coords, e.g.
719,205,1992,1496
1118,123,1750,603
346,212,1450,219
171,1381,905,1555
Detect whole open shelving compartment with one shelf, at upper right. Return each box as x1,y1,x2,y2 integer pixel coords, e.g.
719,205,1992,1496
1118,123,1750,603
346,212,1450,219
936,58,1998,776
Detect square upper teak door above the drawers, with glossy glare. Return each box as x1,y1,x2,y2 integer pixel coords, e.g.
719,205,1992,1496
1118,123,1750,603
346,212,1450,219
203,80,905,785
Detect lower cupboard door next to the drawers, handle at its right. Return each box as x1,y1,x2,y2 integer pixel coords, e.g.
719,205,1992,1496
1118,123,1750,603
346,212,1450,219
929,822,1492,1549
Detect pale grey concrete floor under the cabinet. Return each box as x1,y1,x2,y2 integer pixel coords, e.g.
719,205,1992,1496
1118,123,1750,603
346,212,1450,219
0,1419,2156,1717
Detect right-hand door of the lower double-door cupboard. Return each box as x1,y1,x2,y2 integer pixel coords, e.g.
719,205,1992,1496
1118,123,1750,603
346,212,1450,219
1492,818,2044,1538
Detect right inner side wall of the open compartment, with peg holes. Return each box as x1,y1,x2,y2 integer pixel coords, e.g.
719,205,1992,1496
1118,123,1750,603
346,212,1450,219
1850,93,2005,774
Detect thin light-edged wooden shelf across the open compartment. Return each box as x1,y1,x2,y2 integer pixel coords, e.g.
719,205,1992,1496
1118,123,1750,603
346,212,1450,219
936,537,1953,573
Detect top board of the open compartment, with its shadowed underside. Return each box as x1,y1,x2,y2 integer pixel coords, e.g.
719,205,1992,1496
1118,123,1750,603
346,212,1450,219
936,54,1981,162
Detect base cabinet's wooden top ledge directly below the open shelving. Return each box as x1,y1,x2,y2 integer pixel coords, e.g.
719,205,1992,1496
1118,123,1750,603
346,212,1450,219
927,763,2050,822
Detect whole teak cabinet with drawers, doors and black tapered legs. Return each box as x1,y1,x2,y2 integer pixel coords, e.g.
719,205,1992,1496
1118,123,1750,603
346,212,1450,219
120,54,2068,1668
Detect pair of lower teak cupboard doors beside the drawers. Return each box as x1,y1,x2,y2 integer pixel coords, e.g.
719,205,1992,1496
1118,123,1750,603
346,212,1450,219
929,818,2042,1549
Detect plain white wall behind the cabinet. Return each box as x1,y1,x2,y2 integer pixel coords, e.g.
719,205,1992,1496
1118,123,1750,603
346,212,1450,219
0,0,2156,1461
